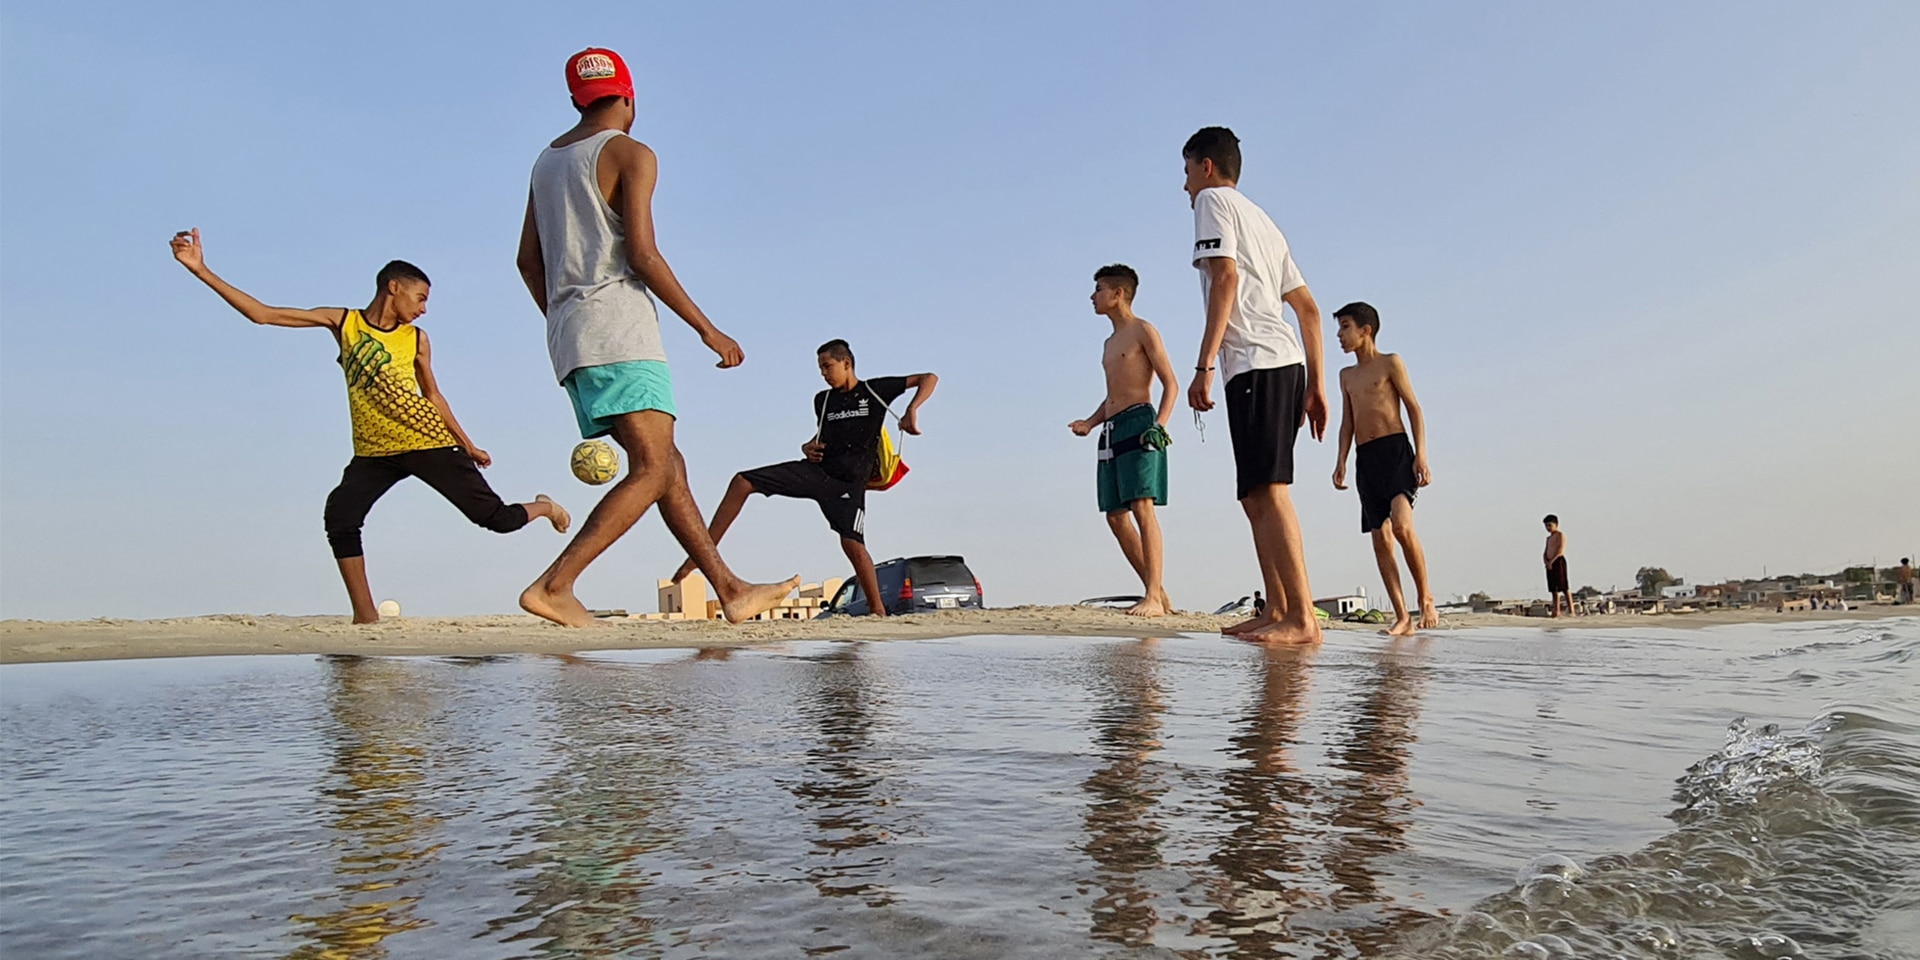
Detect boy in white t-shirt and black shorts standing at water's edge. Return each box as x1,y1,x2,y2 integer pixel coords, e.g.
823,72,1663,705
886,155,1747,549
1181,127,1327,643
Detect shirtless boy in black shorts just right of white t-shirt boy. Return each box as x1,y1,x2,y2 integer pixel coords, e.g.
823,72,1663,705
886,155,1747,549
1332,303,1440,637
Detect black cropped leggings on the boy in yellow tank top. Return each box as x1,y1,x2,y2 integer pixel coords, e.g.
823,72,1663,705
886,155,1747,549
326,447,526,561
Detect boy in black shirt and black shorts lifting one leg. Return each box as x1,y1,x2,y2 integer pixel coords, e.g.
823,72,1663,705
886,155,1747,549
674,340,941,616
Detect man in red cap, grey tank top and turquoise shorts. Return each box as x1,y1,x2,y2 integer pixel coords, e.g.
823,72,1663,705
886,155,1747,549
518,48,801,626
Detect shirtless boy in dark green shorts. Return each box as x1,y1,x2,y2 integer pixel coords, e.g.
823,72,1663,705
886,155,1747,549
1068,263,1181,616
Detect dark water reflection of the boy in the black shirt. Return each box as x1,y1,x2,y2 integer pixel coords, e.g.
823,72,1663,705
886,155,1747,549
787,643,895,906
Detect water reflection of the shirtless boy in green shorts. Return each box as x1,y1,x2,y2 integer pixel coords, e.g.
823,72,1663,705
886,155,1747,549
1081,639,1167,947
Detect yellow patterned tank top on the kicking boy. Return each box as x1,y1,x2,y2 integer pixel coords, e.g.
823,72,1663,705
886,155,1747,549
340,309,459,457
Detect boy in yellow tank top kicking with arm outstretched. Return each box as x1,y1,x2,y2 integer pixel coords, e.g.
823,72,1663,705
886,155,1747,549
173,230,572,624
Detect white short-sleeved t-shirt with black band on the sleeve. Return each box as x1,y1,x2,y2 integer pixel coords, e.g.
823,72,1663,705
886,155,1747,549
1194,186,1308,382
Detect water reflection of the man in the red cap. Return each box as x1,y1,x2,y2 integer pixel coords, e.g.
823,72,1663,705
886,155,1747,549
490,657,685,956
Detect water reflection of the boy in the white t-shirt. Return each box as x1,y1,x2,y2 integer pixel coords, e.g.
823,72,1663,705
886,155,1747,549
1206,645,1317,956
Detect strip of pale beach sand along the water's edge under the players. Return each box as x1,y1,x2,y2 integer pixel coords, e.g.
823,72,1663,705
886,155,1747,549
0,607,1920,664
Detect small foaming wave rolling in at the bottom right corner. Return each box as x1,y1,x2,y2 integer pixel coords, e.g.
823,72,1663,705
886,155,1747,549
1390,705,1920,960
